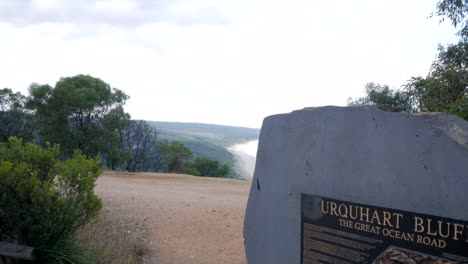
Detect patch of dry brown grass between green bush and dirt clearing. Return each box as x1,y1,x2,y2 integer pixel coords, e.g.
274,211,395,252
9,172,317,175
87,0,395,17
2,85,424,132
78,208,148,264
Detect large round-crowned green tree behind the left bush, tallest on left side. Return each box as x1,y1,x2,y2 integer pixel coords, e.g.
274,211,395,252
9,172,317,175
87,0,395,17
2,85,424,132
29,75,128,157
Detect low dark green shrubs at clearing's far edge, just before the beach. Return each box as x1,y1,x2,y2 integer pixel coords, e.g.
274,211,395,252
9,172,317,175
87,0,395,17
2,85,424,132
183,157,231,178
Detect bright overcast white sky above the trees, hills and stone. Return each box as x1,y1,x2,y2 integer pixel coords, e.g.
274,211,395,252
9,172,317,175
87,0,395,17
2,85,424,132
0,0,456,127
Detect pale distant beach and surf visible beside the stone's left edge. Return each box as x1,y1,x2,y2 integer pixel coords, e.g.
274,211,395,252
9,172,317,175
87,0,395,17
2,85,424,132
227,140,258,181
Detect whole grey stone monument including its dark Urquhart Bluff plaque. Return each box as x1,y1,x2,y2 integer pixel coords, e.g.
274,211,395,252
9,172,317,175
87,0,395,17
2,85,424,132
244,106,468,264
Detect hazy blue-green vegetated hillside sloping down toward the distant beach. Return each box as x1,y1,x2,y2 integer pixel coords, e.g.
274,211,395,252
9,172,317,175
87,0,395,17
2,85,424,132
148,121,260,165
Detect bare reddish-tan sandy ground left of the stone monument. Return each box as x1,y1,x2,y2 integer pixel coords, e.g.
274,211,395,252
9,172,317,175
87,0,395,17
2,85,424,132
96,172,250,264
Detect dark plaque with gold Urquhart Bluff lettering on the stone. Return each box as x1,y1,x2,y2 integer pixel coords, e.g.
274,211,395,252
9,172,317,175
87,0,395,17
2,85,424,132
301,194,468,264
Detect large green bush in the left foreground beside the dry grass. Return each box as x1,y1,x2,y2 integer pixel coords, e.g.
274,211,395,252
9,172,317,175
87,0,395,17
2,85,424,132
0,137,102,264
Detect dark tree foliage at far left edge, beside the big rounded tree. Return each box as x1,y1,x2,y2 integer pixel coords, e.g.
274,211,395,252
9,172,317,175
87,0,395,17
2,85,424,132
0,88,35,142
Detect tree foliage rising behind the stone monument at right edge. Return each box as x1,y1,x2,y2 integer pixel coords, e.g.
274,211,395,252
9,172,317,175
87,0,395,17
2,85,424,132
348,0,468,120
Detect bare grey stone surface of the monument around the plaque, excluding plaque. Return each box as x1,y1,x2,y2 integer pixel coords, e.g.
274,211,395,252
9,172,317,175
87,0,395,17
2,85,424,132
244,106,468,264
